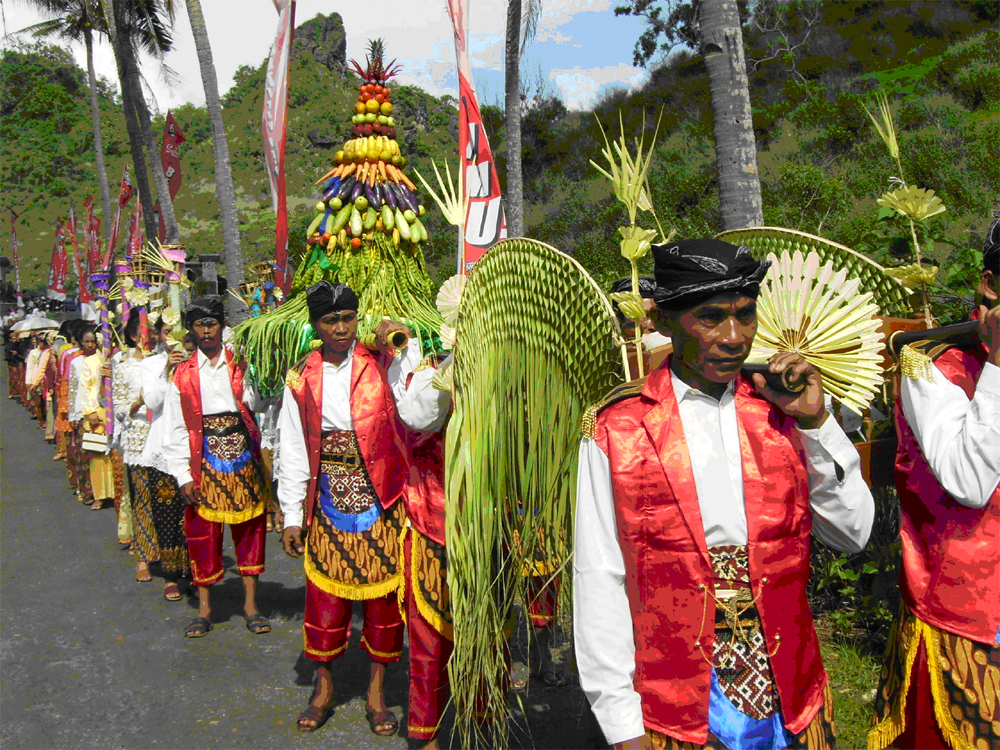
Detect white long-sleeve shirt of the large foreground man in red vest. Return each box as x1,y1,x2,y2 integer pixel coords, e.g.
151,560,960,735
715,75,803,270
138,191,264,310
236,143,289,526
573,374,875,744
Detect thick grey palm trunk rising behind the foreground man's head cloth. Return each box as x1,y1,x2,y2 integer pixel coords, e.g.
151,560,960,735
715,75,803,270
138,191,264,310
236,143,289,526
701,0,764,232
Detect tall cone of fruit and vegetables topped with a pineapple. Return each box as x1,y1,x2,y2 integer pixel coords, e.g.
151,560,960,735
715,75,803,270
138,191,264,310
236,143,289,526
233,39,442,395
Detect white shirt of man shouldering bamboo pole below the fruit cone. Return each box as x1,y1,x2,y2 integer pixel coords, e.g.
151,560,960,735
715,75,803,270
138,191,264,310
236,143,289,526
276,339,433,528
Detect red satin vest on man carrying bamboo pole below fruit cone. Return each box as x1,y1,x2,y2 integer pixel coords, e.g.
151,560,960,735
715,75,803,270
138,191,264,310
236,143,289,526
290,345,405,526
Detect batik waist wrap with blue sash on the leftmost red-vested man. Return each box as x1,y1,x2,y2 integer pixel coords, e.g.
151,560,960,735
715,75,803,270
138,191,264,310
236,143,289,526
198,412,267,524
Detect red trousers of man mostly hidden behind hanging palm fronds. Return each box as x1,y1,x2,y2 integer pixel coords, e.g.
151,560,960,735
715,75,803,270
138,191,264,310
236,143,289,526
402,529,455,741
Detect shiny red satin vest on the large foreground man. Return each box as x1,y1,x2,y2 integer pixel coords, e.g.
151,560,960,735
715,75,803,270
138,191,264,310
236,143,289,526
596,360,827,745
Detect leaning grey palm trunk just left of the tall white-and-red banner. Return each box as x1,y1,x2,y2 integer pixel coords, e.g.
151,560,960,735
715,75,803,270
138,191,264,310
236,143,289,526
187,0,245,325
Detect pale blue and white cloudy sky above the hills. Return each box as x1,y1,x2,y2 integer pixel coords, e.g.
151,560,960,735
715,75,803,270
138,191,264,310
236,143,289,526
2,0,646,111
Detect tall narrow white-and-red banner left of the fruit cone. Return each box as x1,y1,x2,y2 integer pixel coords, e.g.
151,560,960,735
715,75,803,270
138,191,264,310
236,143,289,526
261,0,295,294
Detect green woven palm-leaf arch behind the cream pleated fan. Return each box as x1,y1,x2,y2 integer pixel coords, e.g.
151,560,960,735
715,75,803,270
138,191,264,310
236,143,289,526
715,227,910,317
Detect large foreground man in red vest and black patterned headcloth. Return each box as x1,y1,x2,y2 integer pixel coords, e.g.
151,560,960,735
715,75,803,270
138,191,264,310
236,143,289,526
573,239,874,750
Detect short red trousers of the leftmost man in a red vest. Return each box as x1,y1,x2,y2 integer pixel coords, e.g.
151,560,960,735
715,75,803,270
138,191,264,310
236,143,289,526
184,505,266,586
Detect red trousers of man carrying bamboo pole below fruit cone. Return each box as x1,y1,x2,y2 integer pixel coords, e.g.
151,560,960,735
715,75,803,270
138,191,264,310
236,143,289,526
302,578,403,664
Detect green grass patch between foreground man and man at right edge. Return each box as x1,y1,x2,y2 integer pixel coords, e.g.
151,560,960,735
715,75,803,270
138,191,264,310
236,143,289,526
816,621,882,750
